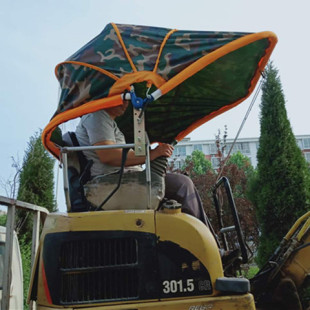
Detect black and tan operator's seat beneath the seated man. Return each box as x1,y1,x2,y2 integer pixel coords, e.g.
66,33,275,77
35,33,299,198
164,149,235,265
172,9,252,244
62,132,167,212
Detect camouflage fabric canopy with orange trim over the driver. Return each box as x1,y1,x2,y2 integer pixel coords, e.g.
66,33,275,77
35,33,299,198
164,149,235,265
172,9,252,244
42,23,277,155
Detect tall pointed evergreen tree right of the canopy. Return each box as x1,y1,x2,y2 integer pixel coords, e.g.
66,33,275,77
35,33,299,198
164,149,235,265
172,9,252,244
252,63,310,265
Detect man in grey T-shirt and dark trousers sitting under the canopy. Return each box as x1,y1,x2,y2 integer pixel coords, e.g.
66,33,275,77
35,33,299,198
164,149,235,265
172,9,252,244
76,101,207,224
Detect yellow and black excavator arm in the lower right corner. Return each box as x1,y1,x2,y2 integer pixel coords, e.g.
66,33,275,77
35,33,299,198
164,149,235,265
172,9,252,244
251,212,310,310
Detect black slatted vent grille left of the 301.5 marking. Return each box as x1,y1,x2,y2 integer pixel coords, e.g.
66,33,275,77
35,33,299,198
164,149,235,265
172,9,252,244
60,238,139,304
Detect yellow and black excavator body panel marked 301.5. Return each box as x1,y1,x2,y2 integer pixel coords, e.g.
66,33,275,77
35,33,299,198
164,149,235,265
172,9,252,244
30,209,255,310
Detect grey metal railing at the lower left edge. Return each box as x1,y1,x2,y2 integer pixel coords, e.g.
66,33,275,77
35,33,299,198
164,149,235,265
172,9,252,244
0,196,49,309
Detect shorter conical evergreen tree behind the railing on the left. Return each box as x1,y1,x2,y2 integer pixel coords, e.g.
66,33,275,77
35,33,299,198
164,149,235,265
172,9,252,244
17,132,56,241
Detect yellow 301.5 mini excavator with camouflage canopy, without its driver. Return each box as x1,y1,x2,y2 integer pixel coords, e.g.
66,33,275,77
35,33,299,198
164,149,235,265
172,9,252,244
22,23,310,310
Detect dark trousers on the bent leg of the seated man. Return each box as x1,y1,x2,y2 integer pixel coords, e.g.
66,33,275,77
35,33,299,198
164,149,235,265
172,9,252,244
165,173,207,224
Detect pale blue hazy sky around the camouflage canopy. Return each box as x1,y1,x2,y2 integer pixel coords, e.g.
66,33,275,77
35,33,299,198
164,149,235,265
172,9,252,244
0,0,310,209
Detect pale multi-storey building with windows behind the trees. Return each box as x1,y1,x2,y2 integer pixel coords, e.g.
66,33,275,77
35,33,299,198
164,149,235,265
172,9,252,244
169,135,310,169
